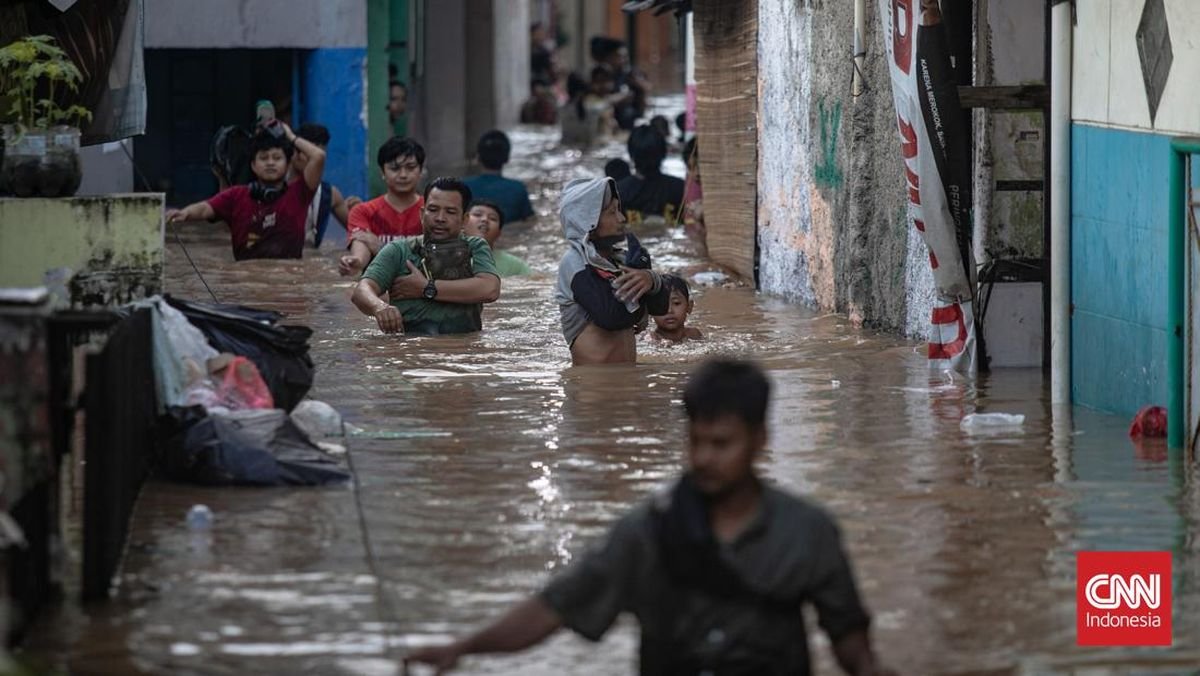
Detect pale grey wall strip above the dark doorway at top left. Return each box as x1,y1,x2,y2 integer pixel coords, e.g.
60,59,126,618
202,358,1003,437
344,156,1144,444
145,0,364,49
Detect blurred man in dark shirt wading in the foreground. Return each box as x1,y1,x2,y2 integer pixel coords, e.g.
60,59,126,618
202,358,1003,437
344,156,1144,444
406,361,892,676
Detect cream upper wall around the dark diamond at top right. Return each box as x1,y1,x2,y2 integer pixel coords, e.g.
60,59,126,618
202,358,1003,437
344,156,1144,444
1072,0,1200,134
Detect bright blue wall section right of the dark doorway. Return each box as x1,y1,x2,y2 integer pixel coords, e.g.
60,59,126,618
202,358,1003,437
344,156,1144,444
301,48,371,199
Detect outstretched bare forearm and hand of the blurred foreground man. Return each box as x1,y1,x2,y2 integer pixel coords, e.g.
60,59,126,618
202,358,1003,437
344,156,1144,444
404,597,563,674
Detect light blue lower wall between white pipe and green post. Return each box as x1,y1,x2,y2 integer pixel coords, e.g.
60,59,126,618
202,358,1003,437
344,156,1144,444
1070,124,1170,415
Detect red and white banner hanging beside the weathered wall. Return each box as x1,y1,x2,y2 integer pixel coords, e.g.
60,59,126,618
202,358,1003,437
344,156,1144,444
878,0,977,377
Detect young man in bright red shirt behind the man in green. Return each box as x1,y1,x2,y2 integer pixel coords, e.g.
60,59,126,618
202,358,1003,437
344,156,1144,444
337,136,425,276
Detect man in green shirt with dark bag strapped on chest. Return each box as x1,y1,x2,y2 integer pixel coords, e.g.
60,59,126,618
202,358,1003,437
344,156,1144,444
352,177,500,335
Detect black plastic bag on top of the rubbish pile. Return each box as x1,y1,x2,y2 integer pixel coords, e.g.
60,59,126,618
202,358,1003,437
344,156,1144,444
166,297,313,411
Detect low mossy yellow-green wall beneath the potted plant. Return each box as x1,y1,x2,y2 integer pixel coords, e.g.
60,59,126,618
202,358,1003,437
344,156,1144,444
0,193,163,305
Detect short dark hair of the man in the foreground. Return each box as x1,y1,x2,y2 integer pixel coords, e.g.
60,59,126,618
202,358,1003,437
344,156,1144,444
683,359,770,429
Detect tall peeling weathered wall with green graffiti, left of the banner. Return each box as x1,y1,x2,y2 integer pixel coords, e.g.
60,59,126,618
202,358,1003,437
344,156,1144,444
753,0,932,335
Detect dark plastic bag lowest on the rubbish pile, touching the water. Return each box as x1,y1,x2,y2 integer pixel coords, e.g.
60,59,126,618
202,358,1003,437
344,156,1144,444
161,407,349,486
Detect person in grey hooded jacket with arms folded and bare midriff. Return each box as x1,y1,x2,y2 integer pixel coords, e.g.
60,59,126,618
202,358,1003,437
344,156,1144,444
554,178,671,366
